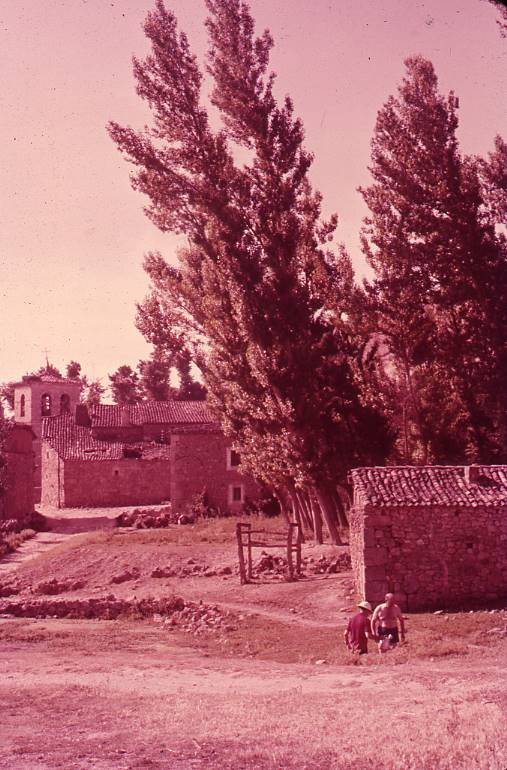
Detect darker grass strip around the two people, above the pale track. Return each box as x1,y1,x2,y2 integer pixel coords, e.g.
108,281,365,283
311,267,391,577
0,612,507,668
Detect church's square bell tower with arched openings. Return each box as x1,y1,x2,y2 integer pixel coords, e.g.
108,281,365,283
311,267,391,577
14,374,81,502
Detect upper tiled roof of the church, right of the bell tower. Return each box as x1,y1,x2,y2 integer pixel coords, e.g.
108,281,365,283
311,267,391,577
90,401,216,428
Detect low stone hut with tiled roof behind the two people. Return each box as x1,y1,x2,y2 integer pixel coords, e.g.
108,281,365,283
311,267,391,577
349,466,507,611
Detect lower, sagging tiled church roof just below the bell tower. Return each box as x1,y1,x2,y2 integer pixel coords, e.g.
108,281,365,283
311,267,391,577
42,415,170,460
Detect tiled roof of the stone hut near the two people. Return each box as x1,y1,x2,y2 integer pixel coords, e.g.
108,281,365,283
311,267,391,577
350,465,507,507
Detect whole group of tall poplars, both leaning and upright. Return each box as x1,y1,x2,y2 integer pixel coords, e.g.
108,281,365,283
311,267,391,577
109,0,507,541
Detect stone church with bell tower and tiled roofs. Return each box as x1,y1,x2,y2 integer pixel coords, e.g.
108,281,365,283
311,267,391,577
14,375,259,512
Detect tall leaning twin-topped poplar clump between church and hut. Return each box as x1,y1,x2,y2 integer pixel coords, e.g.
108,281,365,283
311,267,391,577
110,0,385,541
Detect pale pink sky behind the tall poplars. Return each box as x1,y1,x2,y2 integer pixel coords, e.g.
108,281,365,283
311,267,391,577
0,0,507,384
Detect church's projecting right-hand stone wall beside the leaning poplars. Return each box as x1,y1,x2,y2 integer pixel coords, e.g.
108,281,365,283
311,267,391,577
171,431,259,512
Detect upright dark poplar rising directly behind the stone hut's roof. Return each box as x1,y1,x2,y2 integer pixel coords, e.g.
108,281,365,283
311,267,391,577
362,57,507,462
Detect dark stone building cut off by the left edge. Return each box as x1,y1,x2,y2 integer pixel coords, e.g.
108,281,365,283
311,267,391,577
0,425,34,521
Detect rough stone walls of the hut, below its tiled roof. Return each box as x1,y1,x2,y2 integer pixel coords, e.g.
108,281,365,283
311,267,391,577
349,505,507,611
